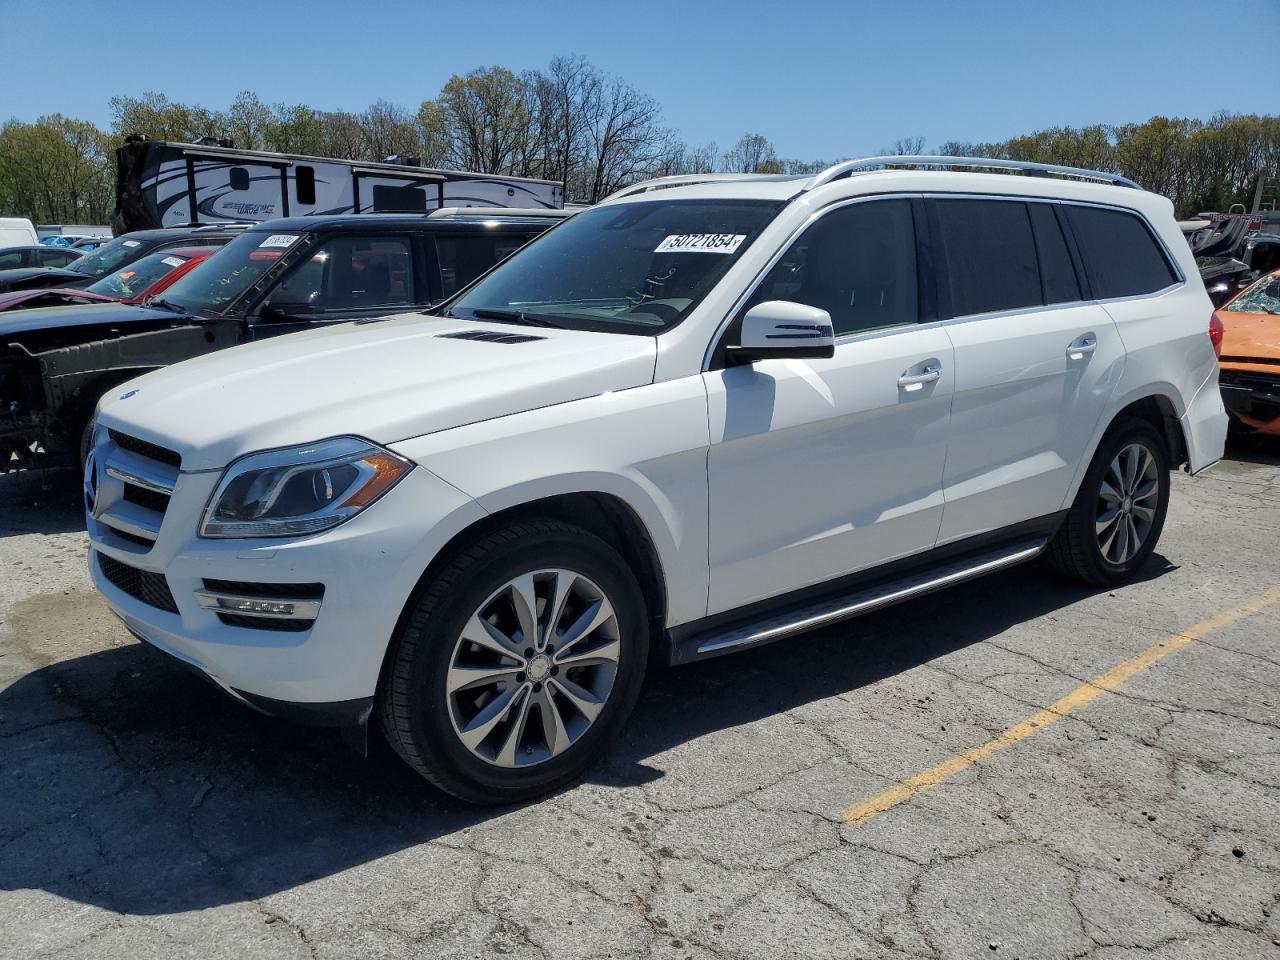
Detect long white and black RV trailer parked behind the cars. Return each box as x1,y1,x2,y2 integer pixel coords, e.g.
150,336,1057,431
111,137,564,233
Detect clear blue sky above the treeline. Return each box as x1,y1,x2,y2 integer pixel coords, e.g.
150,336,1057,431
0,0,1280,159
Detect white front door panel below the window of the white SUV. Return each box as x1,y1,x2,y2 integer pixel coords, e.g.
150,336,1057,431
703,326,955,614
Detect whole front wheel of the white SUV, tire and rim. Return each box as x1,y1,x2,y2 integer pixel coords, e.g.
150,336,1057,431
380,521,649,804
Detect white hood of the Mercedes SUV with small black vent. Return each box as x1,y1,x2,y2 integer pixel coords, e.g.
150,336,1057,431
97,311,657,471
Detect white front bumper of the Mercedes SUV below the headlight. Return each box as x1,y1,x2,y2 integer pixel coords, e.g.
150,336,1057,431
87,455,484,711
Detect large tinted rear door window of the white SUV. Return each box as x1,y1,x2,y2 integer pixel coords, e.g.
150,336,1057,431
933,200,1042,316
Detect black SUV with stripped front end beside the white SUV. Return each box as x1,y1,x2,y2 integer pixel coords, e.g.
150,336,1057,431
0,210,564,465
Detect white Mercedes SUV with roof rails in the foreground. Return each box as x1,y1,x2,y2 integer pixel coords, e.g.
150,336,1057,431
86,157,1226,803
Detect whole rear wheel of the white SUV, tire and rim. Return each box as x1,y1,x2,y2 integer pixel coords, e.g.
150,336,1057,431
1050,417,1169,586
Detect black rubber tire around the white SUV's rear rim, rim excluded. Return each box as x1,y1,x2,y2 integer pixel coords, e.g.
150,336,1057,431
1048,417,1170,586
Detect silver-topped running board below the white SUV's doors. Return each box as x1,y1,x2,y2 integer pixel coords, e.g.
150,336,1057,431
690,536,1048,659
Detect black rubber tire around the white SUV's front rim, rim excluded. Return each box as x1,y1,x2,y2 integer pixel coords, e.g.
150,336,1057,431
379,521,649,805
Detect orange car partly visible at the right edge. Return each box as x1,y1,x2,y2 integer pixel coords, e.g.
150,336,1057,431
1213,270,1280,436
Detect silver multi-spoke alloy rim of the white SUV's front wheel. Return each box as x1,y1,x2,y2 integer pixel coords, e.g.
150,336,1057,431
445,570,621,768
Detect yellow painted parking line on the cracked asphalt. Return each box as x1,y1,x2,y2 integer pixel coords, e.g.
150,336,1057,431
841,585,1280,826
